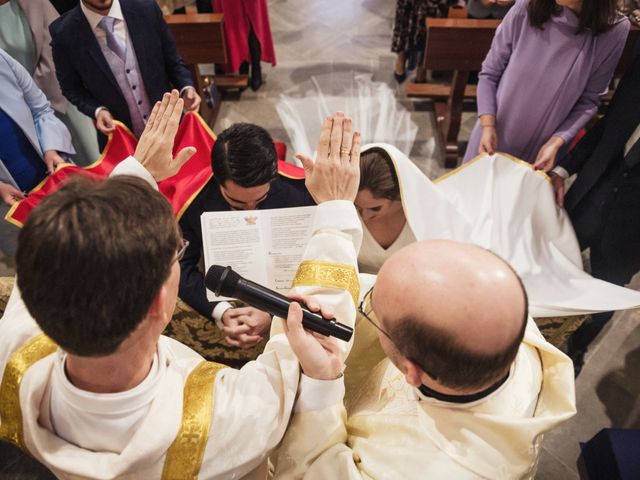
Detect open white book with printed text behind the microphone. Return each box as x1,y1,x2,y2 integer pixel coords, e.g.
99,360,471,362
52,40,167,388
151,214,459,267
200,207,316,301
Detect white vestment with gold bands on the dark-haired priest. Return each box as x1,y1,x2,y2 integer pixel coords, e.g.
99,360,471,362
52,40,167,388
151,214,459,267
0,159,362,479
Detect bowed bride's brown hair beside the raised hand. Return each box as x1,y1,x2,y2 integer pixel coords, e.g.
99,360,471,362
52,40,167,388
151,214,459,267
358,147,400,200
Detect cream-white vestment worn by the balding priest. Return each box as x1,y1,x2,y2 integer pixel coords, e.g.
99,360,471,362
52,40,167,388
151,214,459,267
277,314,576,480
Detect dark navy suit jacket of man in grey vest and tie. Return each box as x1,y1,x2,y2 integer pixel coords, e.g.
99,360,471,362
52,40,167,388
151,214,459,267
49,0,194,128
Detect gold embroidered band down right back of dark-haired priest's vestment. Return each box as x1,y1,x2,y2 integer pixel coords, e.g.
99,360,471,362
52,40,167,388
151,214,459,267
162,361,226,480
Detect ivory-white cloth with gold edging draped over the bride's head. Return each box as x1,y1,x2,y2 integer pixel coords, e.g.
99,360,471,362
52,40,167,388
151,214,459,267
362,143,640,317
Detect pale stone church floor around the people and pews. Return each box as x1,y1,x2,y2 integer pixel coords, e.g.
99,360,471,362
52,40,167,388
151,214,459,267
0,0,640,480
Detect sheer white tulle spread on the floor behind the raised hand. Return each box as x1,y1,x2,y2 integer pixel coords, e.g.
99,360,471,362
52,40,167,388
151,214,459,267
276,72,418,161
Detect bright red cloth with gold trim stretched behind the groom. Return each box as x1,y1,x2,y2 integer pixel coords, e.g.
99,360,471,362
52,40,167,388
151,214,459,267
5,113,304,227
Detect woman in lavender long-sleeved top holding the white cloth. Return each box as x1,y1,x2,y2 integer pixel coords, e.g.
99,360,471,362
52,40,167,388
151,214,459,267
464,0,629,171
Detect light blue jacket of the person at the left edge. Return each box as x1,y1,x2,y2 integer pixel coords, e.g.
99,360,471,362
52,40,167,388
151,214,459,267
0,49,76,187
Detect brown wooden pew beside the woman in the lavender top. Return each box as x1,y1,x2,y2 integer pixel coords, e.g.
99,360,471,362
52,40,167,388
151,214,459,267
406,18,640,168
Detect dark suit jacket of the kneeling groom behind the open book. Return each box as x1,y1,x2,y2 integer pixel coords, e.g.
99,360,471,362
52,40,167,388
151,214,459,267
178,176,315,318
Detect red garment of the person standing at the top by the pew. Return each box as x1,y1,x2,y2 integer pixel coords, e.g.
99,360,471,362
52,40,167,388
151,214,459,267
211,0,276,73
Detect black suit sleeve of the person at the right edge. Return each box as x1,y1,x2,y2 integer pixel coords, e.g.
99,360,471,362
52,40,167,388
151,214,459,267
558,55,640,213
